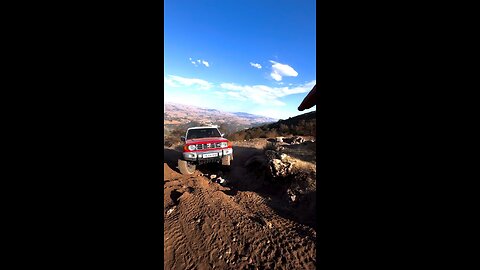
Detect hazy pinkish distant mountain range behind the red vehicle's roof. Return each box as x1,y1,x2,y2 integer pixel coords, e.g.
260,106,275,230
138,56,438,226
163,103,278,133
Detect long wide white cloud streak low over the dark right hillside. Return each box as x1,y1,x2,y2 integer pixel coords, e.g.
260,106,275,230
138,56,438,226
220,80,316,106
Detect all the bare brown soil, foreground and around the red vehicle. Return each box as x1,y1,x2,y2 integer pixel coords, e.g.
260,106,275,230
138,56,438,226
164,142,316,269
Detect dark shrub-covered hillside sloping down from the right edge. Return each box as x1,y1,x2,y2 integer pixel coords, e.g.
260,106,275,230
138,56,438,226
228,111,317,141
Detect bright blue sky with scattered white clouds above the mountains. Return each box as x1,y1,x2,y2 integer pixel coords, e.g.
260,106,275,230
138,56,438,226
164,0,316,119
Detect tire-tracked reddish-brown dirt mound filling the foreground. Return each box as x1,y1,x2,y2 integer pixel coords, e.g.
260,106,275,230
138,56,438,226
164,159,316,269
